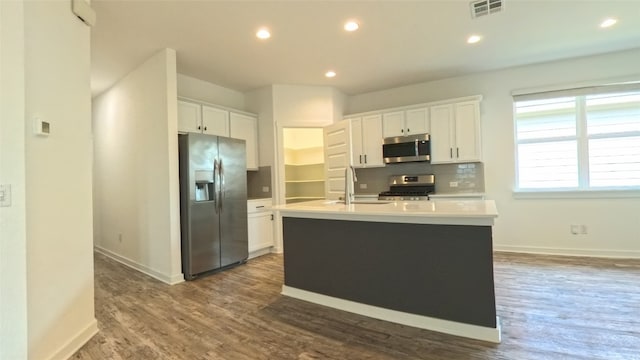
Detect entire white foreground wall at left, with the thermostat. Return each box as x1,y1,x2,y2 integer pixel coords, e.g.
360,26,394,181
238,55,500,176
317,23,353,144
0,1,98,359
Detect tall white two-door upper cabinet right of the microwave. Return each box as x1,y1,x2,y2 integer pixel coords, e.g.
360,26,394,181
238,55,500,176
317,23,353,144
430,101,482,164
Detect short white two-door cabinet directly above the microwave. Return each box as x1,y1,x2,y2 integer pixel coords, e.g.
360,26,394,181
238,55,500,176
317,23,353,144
382,107,429,138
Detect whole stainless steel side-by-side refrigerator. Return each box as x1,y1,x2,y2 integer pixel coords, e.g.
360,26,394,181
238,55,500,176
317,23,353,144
178,134,248,280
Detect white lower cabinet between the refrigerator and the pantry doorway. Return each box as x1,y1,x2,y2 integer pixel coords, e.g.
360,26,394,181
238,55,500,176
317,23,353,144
247,199,274,259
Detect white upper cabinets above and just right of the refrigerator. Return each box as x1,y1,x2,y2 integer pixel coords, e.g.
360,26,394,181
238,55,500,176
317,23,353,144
178,100,259,170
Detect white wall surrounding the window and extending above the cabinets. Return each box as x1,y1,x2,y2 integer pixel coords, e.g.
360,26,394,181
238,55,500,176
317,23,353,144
347,50,640,257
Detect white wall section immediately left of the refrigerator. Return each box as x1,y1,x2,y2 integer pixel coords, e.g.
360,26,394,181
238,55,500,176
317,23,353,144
93,49,183,284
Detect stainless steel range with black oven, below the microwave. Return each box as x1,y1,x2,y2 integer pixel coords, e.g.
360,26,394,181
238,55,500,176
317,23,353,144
378,174,436,201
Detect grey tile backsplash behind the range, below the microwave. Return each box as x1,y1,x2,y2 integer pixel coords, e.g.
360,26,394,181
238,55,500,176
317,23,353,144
356,162,484,195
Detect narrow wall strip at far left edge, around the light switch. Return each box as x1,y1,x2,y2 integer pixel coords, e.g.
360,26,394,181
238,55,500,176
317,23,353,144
0,1,28,359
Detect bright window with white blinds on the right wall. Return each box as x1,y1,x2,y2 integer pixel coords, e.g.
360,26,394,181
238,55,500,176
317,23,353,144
514,84,640,191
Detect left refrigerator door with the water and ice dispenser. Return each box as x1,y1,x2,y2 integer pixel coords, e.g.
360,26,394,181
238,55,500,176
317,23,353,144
179,134,221,280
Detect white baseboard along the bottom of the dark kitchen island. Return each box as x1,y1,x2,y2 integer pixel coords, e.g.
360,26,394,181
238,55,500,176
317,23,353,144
282,285,501,343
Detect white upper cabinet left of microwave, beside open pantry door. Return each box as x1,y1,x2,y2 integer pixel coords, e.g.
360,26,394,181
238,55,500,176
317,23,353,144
347,114,384,168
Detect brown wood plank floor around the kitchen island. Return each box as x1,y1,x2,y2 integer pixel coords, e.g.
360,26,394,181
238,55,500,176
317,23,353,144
73,253,640,360
